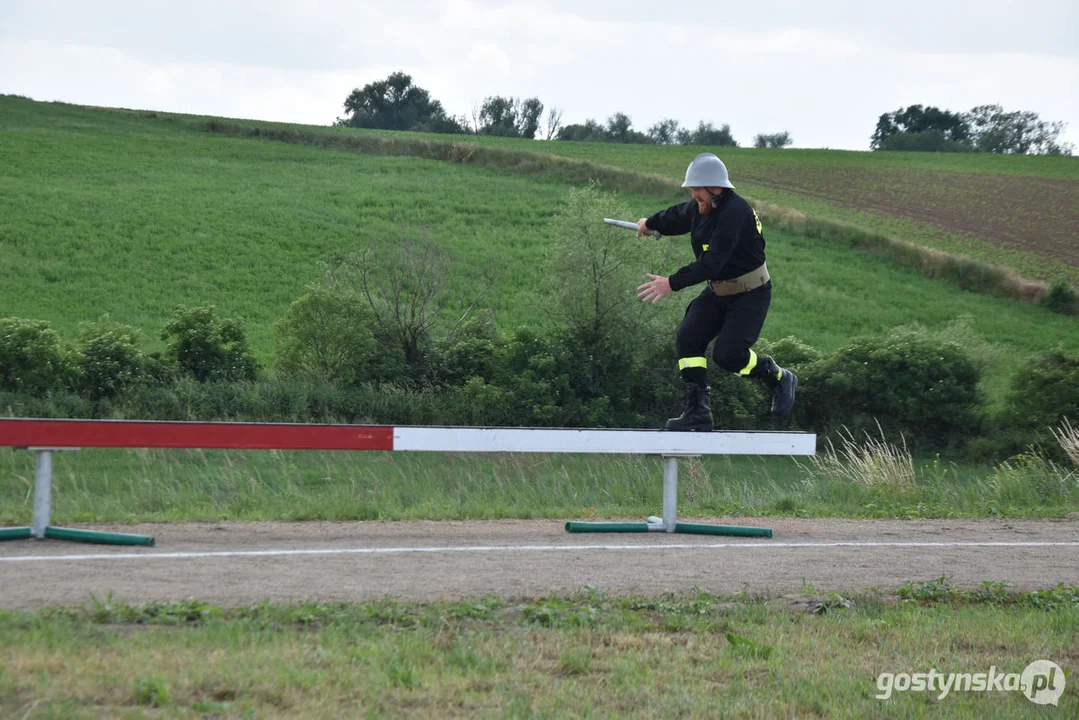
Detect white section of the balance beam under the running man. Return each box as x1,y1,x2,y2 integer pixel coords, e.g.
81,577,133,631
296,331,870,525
394,426,817,456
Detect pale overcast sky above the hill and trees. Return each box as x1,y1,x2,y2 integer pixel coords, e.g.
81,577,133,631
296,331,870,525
0,0,1079,150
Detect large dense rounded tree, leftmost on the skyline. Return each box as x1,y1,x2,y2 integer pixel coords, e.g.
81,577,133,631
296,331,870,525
337,71,465,133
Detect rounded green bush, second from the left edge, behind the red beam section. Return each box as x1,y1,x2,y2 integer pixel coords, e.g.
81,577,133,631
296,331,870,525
74,315,147,400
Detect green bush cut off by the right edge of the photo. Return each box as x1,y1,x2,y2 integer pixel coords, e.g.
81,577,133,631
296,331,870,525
1008,345,1079,430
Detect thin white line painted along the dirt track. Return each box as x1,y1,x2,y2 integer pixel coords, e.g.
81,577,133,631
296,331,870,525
0,541,1079,562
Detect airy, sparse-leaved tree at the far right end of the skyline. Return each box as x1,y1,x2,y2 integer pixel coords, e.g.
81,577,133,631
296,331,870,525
964,105,1074,155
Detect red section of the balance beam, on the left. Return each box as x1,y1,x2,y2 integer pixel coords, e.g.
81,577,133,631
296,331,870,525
0,419,394,450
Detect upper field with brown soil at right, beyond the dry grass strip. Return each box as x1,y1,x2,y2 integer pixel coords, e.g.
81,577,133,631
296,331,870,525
76,102,1079,285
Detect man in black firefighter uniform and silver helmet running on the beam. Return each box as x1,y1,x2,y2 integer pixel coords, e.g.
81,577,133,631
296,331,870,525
637,152,798,432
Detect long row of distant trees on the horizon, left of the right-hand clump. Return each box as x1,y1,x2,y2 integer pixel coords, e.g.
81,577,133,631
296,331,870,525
336,71,793,148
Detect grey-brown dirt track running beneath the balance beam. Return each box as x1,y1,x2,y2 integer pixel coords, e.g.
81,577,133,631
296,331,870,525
0,518,1079,608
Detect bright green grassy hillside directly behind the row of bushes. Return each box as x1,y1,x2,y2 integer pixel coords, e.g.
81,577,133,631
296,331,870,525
0,97,1079,410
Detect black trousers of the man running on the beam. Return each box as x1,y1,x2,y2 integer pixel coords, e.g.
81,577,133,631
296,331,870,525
677,283,771,375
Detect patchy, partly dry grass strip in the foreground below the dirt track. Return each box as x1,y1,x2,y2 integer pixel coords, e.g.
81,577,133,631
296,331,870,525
0,580,1079,720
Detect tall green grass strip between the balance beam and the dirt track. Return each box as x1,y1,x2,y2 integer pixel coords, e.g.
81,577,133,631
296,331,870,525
0,444,1079,526
